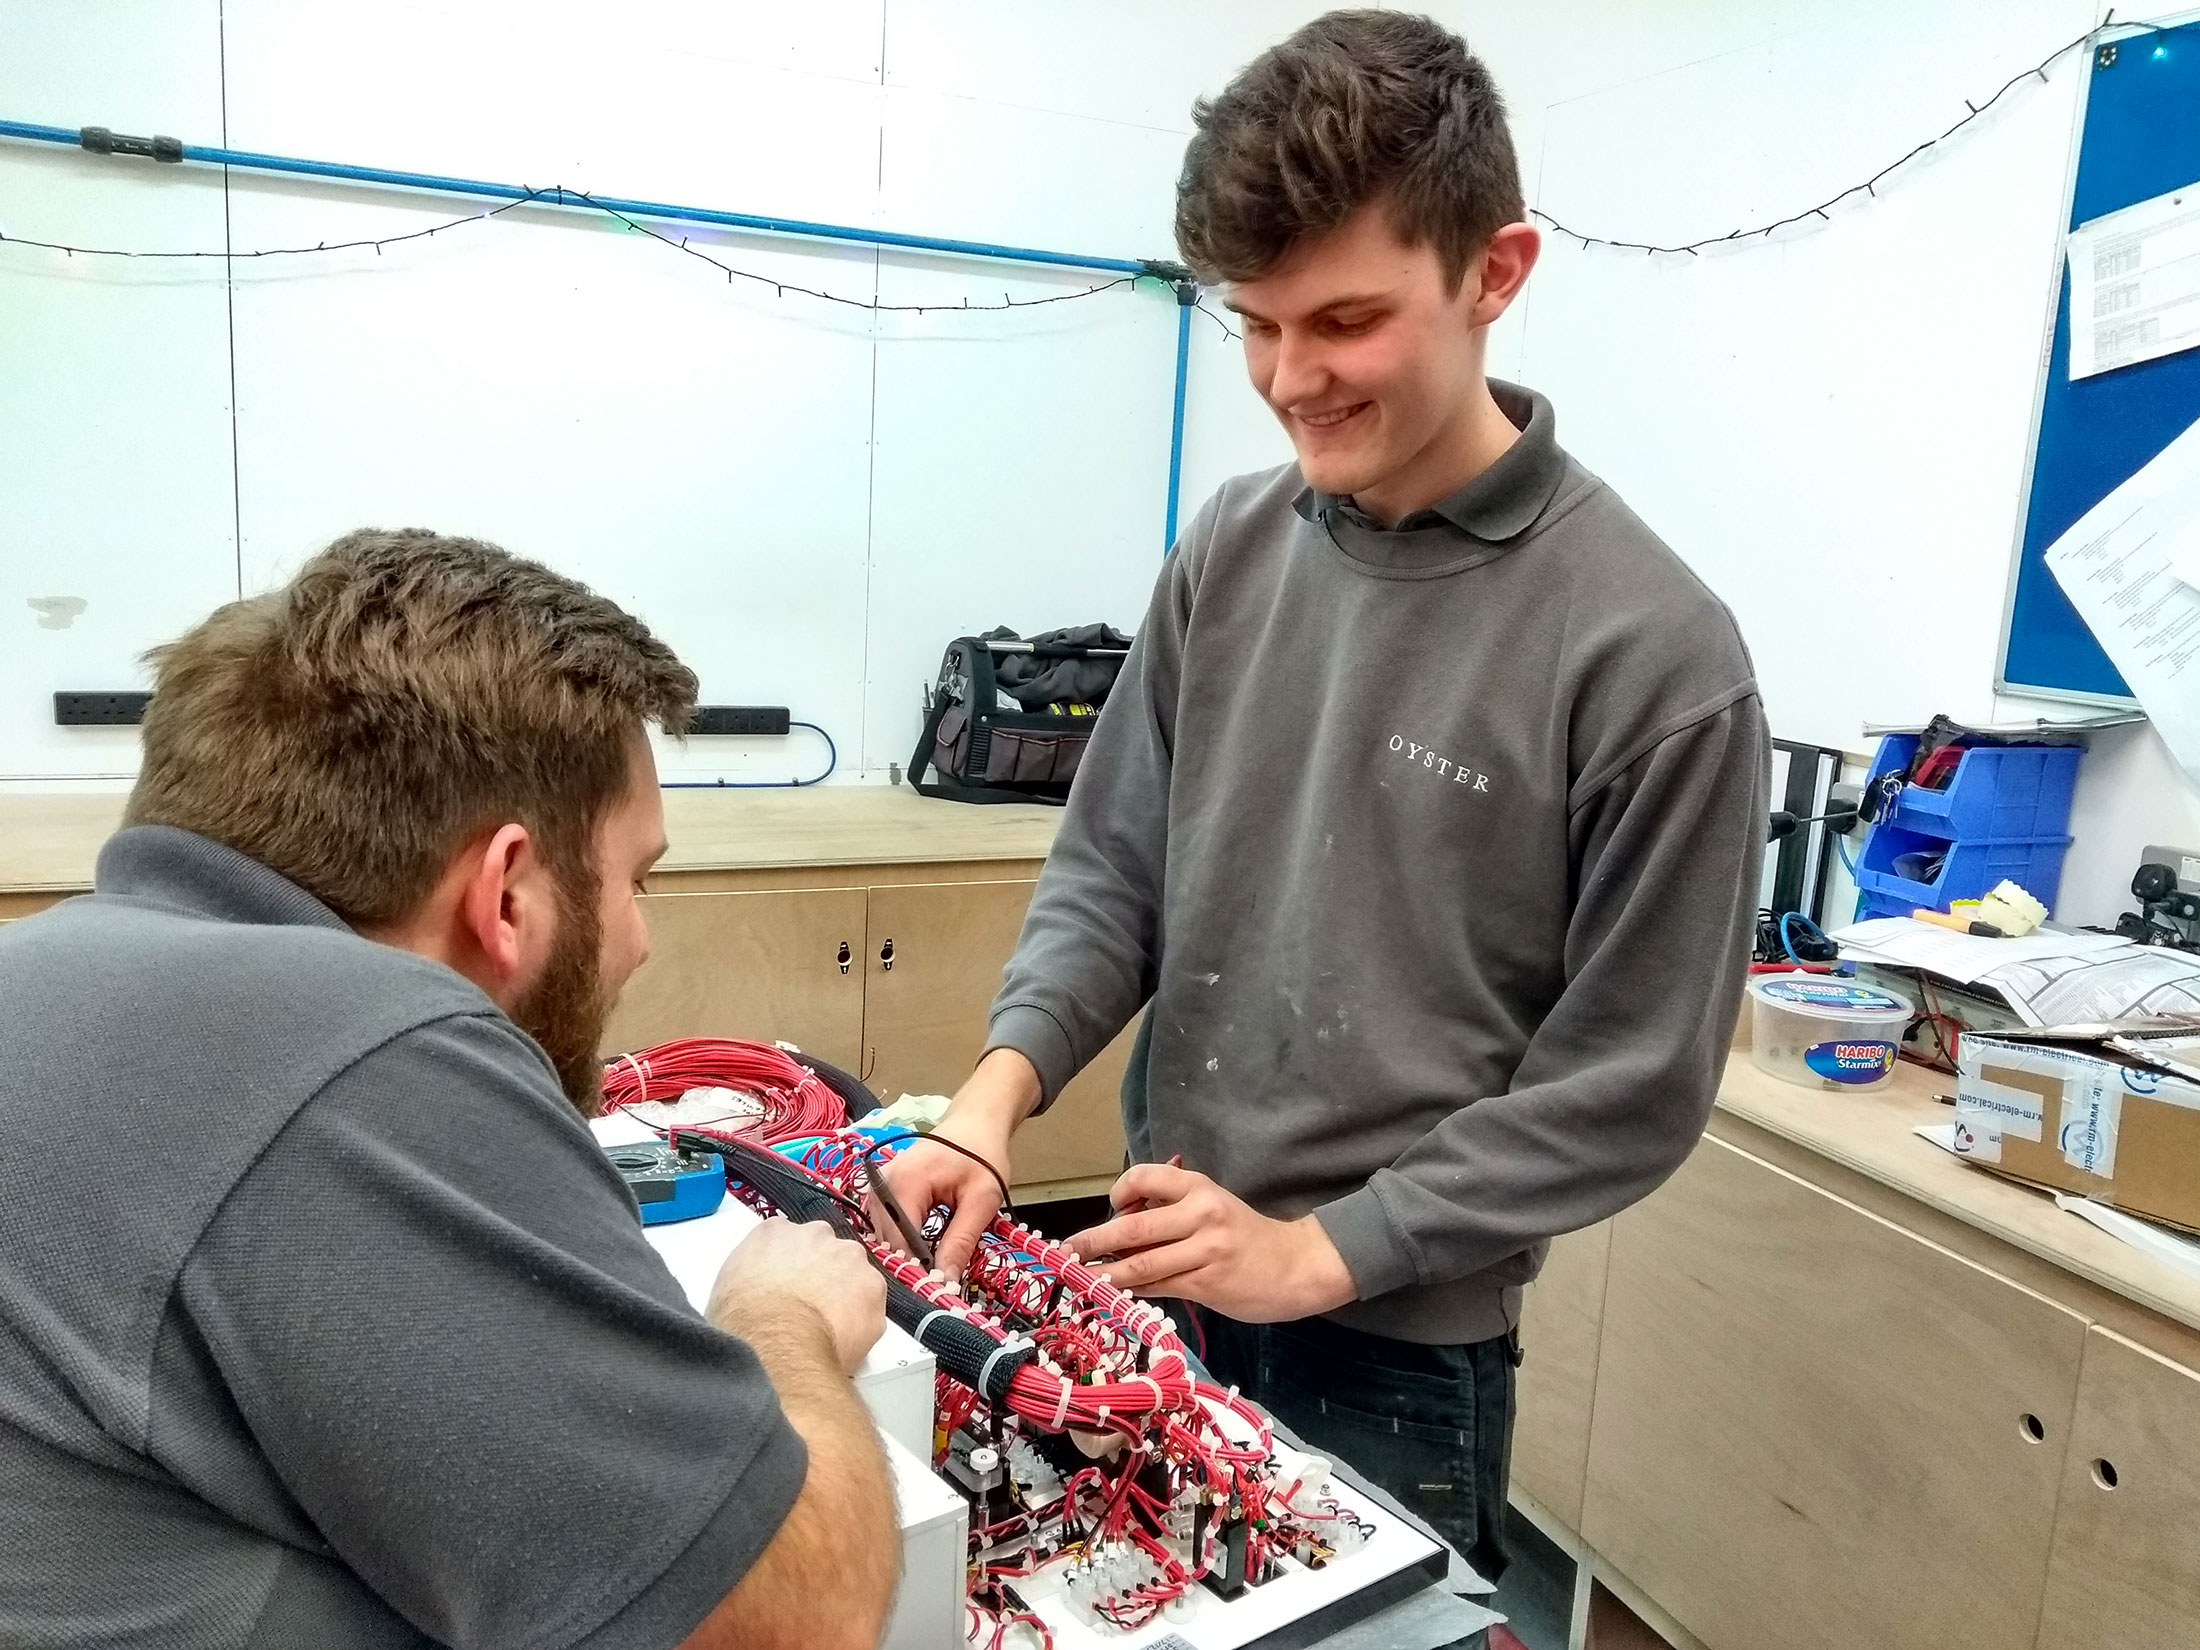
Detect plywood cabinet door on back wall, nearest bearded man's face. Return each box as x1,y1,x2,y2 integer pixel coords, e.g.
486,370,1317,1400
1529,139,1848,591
603,889,865,1071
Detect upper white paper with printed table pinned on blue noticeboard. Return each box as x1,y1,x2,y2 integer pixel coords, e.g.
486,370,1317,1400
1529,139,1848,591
2068,183,2200,378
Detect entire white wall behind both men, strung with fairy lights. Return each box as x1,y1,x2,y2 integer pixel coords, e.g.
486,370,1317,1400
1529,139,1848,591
0,0,2200,884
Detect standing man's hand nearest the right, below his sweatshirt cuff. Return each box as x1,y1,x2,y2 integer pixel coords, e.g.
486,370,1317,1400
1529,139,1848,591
1069,1164,1357,1324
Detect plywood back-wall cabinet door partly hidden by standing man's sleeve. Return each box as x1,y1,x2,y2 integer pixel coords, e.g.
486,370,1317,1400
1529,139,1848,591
862,880,1131,1195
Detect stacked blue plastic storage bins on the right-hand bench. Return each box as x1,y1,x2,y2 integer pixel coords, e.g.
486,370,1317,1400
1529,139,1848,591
1857,733,2086,920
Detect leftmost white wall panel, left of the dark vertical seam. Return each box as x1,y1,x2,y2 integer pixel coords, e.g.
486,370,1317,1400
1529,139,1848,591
0,0,238,774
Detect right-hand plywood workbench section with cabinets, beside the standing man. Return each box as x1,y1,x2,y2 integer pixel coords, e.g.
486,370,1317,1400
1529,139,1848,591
1511,1052,2200,1650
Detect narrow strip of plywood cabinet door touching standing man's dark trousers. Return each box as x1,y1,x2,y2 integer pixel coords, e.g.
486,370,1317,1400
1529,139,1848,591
1511,1221,1613,1531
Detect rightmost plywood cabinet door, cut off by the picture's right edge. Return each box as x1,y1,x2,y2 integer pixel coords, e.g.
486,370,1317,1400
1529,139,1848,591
2039,1329,2200,1650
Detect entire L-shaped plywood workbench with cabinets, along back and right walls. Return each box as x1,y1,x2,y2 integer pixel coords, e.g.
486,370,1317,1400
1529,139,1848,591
0,788,2200,1650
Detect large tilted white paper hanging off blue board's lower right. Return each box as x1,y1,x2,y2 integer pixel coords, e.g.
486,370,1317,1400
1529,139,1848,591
2044,411,2200,781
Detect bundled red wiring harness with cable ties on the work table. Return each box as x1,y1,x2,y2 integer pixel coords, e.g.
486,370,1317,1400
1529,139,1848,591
605,1043,1371,1650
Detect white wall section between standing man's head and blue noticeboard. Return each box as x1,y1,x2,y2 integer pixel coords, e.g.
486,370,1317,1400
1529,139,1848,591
1522,0,2083,746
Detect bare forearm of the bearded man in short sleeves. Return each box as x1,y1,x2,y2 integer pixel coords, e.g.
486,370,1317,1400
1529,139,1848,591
682,1296,902,1650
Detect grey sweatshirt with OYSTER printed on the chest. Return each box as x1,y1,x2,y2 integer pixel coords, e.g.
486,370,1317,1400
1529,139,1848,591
988,383,1769,1342
